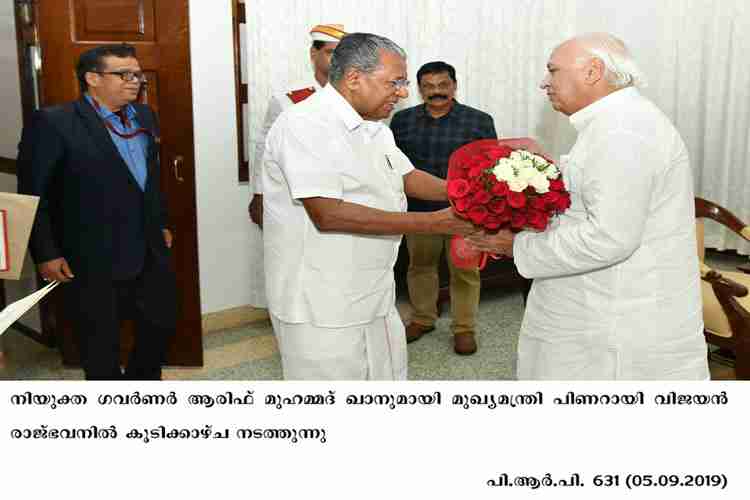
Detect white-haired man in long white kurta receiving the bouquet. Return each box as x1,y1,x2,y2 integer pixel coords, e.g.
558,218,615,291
470,33,709,380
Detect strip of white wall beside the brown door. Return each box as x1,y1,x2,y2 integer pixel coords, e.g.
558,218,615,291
190,0,258,314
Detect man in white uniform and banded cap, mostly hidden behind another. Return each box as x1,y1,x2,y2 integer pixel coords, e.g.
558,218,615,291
247,24,346,307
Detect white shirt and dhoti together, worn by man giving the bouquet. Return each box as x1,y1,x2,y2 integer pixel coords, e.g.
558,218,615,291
263,85,414,380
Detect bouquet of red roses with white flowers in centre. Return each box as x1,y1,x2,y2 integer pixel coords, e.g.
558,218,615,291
447,139,570,269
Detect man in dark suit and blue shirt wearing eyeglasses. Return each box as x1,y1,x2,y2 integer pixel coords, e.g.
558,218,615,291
18,44,176,380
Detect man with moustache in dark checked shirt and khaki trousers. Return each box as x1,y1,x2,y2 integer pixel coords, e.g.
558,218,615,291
391,61,497,354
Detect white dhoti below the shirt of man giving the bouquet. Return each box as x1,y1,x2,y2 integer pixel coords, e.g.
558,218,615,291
271,307,407,380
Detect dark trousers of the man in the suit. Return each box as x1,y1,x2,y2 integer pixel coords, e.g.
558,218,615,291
66,254,175,380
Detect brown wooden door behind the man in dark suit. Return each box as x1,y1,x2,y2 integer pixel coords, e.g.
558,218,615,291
35,0,203,366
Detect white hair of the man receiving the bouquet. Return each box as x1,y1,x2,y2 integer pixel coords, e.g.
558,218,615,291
575,33,647,89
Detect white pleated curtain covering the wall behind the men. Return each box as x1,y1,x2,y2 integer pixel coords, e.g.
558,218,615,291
245,0,750,254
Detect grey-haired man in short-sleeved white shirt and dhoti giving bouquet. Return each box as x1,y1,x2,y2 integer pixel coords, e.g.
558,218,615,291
262,33,473,380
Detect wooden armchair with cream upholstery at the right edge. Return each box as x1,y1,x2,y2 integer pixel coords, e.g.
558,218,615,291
695,198,750,380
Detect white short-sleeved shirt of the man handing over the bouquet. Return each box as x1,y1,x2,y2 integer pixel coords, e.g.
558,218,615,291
262,85,414,328
